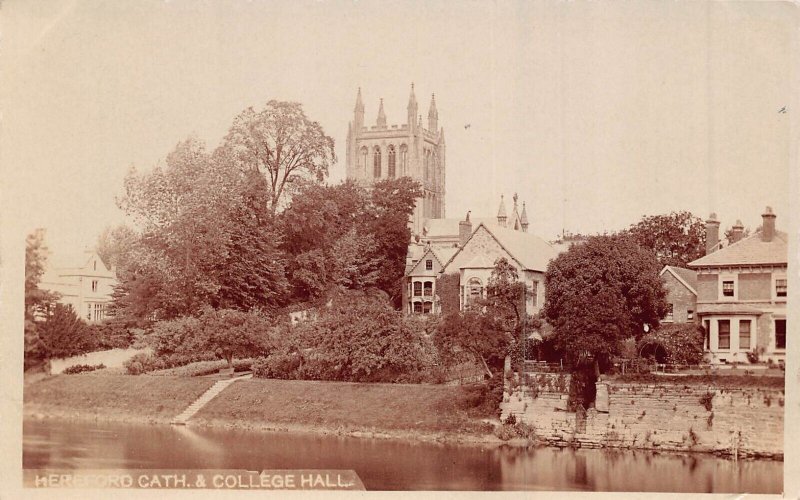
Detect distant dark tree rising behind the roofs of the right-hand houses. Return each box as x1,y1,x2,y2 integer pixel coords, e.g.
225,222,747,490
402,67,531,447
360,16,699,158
624,211,706,267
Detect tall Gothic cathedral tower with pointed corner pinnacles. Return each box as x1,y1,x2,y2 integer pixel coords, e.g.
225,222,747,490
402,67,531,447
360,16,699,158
346,83,445,234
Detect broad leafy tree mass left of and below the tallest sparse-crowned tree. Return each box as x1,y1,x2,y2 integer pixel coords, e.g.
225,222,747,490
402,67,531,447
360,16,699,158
114,139,286,318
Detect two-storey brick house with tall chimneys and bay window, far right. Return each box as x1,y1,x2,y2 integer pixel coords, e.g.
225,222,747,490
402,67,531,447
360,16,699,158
688,207,788,363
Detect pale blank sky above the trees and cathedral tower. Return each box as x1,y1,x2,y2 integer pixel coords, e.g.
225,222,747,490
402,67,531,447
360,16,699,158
0,0,797,261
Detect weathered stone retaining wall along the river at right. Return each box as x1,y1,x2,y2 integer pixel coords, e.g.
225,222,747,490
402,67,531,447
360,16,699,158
502,380,784,458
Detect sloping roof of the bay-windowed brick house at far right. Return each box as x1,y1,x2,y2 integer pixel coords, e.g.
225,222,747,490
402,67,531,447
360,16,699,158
687,231,789,268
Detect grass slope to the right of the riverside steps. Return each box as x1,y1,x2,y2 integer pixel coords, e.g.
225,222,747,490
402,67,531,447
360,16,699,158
193,379,486,434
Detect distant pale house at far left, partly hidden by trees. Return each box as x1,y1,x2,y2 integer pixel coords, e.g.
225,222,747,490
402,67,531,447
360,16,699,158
39,250,117,322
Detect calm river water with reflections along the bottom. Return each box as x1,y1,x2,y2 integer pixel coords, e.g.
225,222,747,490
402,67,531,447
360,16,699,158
22,420,783,493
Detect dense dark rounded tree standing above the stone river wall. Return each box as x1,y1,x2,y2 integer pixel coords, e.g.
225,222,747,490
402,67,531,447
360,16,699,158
542,235,667,372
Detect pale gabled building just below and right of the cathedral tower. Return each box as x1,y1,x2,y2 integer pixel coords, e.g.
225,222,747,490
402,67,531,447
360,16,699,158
442,220,556,314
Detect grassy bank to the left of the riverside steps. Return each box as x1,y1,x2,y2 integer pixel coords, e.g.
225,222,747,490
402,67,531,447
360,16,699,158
24,373,214,422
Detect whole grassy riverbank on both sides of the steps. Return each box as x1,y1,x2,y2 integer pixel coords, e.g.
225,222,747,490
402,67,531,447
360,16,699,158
24,373,506,444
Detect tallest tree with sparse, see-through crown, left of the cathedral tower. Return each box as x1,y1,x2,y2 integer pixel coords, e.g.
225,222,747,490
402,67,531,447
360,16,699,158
216,100,336,214
